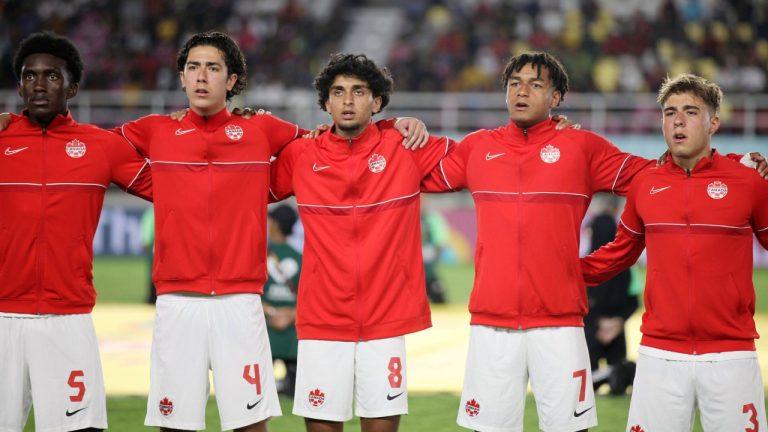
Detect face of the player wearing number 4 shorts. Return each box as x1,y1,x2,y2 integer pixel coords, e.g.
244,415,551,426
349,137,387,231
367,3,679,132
179,45,237,116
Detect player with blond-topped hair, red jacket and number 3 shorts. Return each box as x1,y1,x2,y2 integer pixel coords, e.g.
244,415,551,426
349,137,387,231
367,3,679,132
582,74,768,432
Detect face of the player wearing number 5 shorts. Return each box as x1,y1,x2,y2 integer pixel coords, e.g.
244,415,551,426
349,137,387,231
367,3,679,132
18,54,77,125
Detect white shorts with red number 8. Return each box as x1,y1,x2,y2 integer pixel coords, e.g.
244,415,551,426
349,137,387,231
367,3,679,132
293,336,408,422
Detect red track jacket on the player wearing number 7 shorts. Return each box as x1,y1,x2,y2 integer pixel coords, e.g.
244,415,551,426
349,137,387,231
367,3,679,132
423,120,654,329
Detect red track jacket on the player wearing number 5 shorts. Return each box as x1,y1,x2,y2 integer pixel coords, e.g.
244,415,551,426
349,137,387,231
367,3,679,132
0,114,152,314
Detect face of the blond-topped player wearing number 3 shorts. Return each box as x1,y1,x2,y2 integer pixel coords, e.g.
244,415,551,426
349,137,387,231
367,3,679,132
662,92,720,168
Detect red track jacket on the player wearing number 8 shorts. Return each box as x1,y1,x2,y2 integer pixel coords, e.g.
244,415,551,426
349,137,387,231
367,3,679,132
271,124,452,341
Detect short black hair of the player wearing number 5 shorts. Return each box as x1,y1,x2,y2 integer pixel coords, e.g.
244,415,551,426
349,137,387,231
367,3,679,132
13,32,83,84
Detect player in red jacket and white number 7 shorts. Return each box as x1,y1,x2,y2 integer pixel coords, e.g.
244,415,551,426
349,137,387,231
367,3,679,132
423,52,765,432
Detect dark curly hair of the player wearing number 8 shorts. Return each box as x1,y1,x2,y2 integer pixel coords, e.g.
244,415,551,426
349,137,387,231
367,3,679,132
315,54,394,114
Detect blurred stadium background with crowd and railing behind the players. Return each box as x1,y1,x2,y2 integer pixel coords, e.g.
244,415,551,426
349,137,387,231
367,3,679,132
0,0,768,430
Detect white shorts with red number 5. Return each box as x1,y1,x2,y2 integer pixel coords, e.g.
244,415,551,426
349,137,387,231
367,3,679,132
0,314,107,432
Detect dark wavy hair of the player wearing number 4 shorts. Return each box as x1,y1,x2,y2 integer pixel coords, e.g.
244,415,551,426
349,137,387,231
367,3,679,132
176,32,248,99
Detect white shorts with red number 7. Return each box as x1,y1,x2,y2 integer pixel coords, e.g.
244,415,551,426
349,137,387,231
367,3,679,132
456,325,597,432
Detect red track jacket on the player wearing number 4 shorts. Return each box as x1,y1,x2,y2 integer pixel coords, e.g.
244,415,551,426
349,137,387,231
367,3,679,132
119,108,304,295
